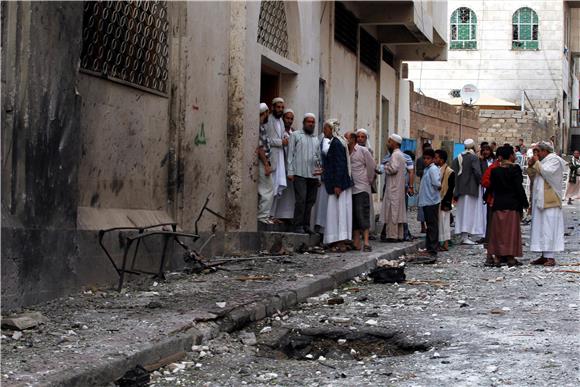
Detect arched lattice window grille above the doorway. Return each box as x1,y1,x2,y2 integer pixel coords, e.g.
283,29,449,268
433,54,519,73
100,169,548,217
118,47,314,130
258,0,288,58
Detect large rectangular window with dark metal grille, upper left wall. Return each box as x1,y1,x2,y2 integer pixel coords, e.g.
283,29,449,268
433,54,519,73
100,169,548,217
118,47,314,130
81,1,169,95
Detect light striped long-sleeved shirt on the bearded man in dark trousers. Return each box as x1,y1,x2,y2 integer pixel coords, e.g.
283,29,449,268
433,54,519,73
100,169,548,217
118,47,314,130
288,130,320,179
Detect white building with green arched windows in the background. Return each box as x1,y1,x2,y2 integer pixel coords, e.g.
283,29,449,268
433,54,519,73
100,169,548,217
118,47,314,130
409,0,577,150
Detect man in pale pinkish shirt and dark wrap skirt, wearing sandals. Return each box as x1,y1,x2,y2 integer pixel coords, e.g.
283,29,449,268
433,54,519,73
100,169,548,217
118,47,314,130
344,132,377,251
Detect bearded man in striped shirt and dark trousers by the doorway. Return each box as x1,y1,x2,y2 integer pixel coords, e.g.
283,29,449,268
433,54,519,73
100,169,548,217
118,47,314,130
288,113,322,233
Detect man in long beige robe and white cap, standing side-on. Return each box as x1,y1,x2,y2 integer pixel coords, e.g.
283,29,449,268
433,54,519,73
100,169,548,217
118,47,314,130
381,134,407,242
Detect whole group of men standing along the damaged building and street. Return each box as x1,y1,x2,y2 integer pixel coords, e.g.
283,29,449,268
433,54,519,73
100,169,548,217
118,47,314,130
256,98,565,266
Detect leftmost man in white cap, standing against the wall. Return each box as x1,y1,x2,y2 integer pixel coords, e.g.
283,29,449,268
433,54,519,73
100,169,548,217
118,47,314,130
256,102,274,224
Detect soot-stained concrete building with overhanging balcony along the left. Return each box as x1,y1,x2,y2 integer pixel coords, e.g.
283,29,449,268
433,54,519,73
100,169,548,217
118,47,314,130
1,0,447,308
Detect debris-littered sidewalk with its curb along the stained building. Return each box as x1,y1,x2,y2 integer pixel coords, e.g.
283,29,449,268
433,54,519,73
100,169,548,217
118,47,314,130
1,239,422,386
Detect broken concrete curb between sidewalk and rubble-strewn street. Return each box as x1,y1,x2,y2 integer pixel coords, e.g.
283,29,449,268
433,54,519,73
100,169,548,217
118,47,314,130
41,240,423,387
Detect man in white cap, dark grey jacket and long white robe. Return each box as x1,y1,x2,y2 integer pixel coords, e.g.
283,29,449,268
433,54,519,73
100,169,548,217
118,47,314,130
451,138,486,245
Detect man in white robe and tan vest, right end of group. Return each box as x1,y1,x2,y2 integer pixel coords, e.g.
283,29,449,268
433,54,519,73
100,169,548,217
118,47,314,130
528,142,566,266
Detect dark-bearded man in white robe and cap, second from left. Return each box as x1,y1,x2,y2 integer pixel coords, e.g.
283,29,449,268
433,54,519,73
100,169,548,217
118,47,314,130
266,97,288,221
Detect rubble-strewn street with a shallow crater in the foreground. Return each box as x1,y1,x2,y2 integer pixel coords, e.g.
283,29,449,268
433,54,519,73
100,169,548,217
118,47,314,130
151,204,580,386
